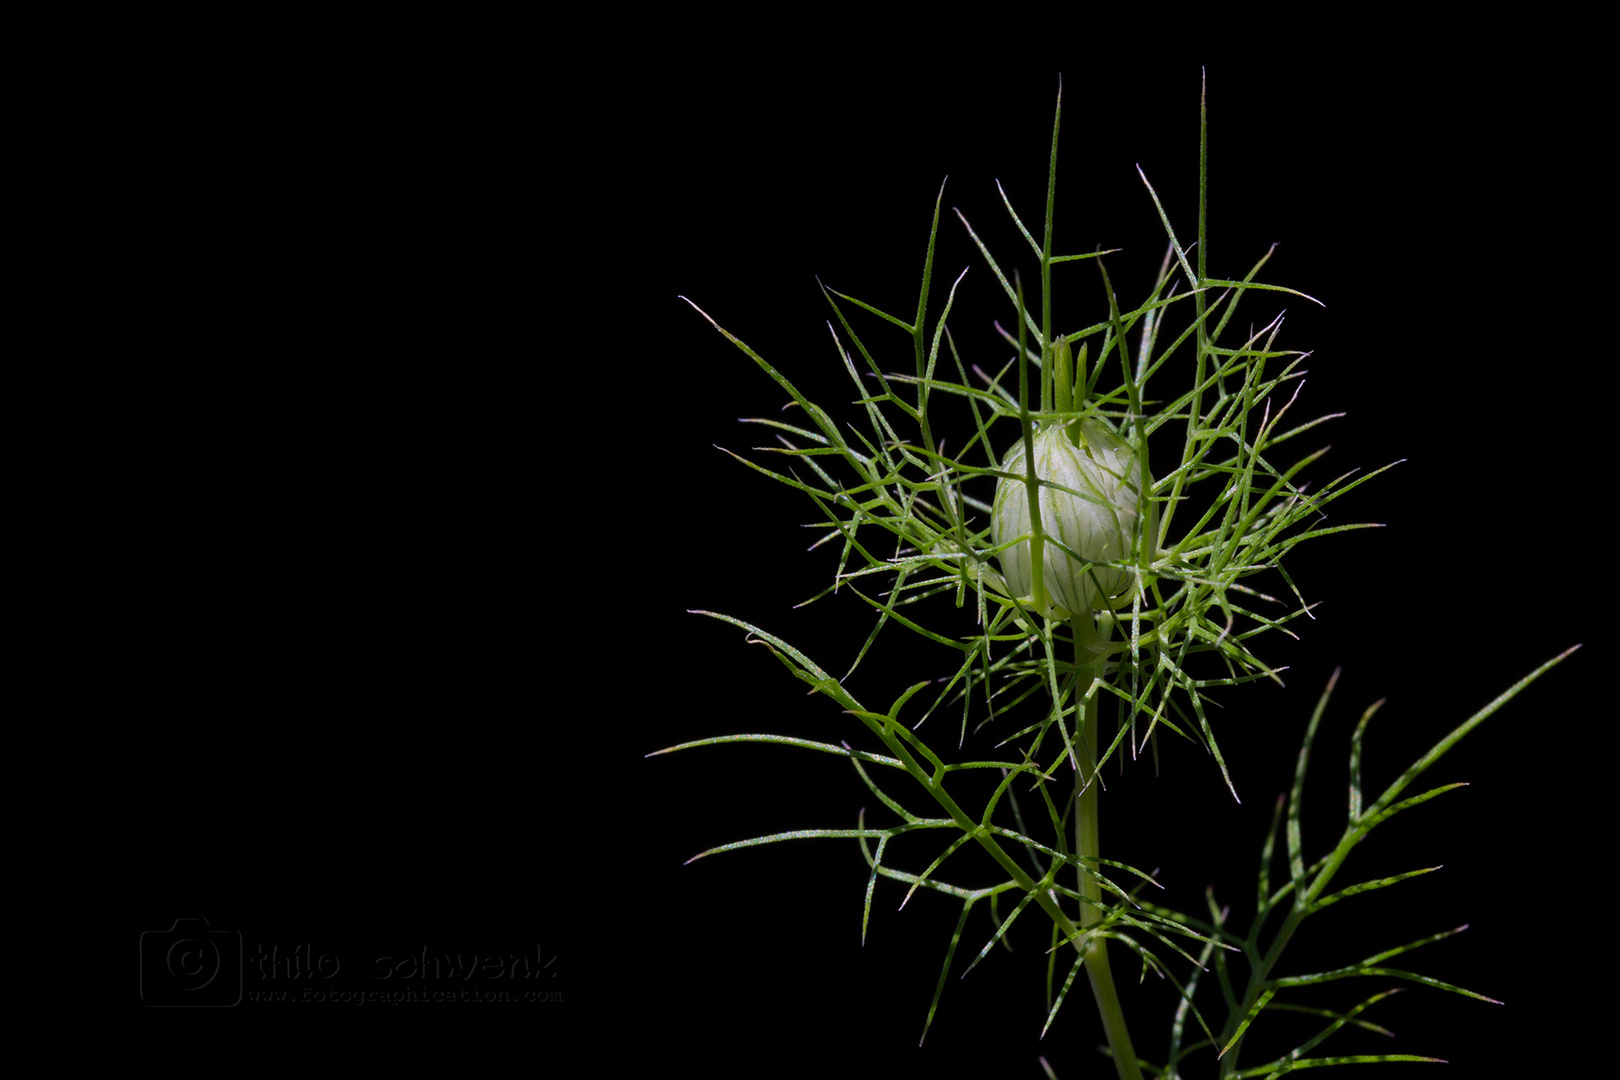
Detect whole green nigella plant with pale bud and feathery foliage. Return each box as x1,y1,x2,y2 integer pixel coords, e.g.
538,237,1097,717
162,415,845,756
659,74,1567,1077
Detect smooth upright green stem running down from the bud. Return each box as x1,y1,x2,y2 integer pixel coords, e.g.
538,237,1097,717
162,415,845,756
1069,612,1142,1080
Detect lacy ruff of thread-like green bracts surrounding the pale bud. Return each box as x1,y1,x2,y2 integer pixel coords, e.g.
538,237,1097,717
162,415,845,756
689,80,1382,799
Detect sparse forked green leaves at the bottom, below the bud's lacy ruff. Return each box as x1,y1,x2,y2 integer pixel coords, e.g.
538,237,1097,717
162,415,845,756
650,612,1580,1077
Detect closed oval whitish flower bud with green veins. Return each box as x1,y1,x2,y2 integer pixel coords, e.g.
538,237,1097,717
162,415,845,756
990,419,1158,619
